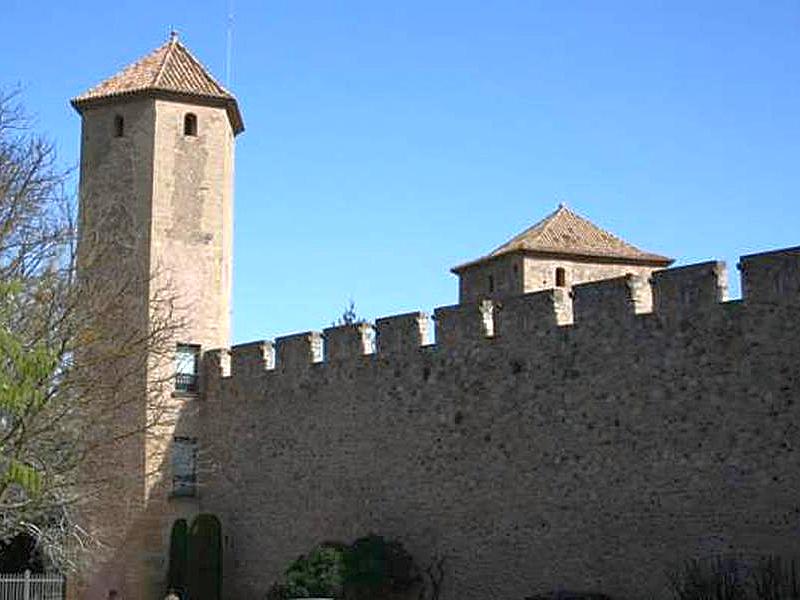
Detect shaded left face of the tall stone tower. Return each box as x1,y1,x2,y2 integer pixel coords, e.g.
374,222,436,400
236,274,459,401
72,99,155,600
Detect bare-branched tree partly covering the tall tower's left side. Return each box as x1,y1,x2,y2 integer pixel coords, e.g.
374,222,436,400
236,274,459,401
0,93,182,570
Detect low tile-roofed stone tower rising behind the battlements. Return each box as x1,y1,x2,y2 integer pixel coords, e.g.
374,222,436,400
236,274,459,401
451,204,673,304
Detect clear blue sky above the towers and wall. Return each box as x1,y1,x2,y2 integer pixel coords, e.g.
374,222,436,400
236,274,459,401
0,0,800,342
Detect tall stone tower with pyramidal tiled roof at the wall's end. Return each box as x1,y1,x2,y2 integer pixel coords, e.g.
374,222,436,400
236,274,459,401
72,34,243,599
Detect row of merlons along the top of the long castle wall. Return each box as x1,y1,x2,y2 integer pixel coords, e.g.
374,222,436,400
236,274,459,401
203,247,800,382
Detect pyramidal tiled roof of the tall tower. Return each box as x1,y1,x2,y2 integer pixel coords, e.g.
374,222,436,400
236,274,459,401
72,34,244,133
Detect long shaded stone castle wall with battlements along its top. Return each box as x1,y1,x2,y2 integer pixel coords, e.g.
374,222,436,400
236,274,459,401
201,249,800,600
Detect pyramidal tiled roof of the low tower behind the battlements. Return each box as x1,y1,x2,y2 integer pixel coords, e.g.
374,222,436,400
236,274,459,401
453,204,673,272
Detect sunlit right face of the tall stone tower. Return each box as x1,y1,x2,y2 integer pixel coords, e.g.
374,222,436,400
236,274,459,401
143,99,234,598
